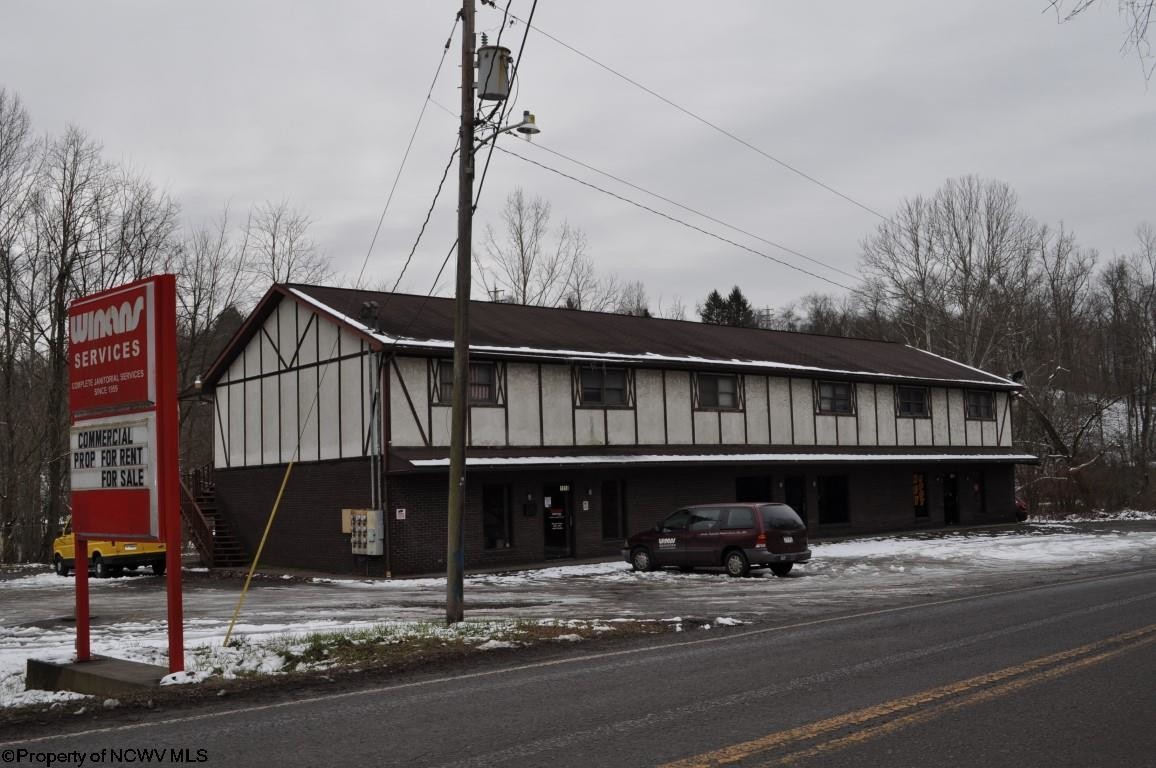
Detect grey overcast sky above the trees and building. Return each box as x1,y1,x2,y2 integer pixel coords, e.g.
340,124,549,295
0,0,1156,311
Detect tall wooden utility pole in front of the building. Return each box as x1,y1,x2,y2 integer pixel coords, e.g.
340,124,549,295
445,0,474,625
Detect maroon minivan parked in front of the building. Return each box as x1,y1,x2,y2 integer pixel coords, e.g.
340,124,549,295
622,502,810,576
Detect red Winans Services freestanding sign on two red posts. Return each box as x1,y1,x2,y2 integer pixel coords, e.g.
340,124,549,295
68,274,185,672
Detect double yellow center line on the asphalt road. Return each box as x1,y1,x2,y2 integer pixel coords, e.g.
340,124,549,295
662,625,1156,768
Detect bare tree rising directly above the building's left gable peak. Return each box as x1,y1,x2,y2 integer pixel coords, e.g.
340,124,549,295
242,200,332,283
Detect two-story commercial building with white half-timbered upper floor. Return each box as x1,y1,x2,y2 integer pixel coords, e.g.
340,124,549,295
196,285,1035,575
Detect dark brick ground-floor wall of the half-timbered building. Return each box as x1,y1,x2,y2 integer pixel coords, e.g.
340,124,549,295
216,459,1015,576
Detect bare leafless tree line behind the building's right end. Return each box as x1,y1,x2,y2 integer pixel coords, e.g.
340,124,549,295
725,176,1156,512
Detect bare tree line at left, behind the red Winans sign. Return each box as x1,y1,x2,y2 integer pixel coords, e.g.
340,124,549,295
0,88,329,562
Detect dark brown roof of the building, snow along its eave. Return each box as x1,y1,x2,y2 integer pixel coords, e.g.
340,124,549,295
284,283,1018,390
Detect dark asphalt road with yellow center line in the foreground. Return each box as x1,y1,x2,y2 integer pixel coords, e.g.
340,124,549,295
0,557,1156,768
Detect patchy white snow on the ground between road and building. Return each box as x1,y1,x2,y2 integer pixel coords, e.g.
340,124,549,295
0,522,1156,707
